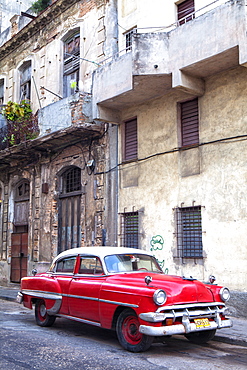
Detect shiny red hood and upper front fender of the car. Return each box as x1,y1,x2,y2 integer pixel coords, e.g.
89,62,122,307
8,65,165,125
104,272,214,305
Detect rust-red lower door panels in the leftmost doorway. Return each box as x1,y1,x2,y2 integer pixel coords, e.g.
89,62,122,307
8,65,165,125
10,233,28,283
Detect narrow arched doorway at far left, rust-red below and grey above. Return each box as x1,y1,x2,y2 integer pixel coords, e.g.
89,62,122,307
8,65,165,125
10,180,30,283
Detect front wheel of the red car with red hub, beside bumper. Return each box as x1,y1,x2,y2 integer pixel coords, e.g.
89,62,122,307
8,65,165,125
116,309,153,352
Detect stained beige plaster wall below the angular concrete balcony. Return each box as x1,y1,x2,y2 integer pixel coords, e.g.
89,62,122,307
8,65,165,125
119,67,247,291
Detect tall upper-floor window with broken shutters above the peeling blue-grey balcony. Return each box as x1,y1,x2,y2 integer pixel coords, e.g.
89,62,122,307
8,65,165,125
63,32,80,97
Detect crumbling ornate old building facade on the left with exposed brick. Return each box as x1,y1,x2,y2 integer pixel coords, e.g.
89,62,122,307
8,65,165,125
0,0,117,283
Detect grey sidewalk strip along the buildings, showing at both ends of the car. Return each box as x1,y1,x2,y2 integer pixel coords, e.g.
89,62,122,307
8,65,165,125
0,284,247,347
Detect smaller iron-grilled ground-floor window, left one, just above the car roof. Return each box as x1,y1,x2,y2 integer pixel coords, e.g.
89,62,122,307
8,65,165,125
120,212,139,248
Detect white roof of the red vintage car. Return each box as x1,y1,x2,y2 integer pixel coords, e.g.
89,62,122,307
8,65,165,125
54,247,152,262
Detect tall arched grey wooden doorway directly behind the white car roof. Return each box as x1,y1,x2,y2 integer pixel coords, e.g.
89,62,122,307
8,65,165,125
58,166,82,253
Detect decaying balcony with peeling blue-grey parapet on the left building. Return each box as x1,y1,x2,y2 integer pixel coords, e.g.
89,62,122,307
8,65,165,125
0,93,104,170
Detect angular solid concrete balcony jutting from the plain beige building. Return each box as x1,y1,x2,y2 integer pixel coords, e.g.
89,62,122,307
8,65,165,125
93,1,247,123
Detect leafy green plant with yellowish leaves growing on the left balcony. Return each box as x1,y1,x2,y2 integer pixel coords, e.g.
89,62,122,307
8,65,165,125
2,100,39,146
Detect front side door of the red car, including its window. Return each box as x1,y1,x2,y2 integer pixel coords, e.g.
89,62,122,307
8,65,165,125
69,255,106,325
